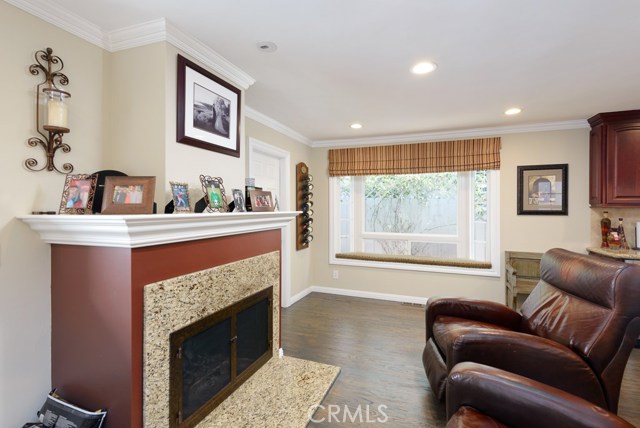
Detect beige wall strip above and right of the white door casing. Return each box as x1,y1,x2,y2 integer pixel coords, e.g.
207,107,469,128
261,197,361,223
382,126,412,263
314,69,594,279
246,119,315,296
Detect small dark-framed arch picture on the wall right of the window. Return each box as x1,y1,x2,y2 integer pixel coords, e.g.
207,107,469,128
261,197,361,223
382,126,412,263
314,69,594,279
518,164,569,215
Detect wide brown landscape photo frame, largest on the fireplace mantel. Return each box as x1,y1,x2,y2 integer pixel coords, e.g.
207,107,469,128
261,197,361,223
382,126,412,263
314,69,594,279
102,176,156,214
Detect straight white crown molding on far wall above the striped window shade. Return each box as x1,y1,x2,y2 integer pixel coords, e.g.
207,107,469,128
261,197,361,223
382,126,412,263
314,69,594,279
311,119,589,148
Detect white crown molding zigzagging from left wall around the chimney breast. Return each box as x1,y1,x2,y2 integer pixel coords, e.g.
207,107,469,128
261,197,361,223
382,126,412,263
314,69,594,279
5,0,255,90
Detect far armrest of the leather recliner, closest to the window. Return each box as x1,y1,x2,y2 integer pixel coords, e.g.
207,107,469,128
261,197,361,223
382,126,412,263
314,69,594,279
425,297,522,340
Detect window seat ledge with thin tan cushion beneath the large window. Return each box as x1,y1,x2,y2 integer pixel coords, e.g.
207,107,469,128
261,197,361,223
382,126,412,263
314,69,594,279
330,252,500,277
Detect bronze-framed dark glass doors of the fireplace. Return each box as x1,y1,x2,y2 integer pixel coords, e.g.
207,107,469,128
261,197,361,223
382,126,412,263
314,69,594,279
169,288,273,428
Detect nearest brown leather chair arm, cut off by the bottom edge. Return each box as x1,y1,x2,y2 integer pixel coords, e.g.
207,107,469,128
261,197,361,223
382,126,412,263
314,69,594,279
446,362,633,428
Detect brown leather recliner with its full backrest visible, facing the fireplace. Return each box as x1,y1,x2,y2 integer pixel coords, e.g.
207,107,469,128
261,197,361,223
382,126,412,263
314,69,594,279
422,249,640,413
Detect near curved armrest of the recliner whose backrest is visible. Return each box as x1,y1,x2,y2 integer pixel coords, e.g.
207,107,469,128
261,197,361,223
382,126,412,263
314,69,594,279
445,331,607,408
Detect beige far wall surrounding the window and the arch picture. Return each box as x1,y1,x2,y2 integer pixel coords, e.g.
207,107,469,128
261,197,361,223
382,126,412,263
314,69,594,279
310,129,591,302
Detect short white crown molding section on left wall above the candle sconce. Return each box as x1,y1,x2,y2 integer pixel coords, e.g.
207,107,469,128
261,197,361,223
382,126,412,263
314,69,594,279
4,0,108,49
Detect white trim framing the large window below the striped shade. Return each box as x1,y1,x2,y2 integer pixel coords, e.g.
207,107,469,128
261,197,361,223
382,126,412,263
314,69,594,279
329,170,502,277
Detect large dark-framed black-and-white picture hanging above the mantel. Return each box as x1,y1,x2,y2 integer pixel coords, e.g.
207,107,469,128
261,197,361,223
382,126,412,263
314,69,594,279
176,55,242,157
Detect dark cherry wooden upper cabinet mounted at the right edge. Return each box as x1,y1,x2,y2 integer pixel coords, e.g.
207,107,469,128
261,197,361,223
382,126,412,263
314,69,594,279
589,110,640,207
